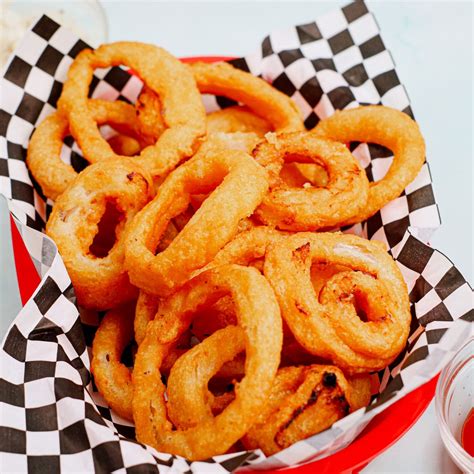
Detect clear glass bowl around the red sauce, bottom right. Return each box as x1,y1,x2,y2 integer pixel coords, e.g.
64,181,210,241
435,336,474,473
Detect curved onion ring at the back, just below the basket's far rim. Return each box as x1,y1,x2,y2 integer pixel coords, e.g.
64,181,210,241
189,62,304,132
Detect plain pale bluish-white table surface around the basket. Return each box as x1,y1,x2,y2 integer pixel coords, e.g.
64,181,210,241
0,0,473,474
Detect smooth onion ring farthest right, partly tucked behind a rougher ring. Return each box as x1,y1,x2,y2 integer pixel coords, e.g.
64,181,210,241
311,105,425,224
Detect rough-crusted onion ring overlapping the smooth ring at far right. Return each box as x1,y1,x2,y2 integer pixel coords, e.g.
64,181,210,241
253,132,369,231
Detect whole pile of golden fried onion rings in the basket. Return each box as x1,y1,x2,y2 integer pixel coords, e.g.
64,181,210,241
27,42,424,460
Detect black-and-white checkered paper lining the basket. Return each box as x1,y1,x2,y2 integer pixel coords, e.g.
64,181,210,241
0,2,473,473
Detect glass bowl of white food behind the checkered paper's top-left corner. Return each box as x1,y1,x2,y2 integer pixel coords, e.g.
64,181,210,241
0,0,109,67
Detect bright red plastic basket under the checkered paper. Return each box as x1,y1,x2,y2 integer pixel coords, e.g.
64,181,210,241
11,56,437,474
